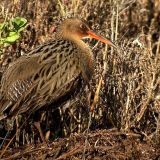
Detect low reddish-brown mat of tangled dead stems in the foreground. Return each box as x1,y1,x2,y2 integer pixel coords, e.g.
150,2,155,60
1,129,160,160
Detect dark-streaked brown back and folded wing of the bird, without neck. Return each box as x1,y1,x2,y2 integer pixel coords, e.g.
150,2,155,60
0,40,80,115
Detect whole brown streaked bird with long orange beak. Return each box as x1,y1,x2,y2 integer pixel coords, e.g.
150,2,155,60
0,18,115,119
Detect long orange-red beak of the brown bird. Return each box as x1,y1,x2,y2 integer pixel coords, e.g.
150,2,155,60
87,31,117,48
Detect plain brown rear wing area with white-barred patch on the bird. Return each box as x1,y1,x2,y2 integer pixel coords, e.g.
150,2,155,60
1,56,41,101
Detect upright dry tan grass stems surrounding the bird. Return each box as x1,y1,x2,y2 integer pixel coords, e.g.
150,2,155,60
0,0,160,159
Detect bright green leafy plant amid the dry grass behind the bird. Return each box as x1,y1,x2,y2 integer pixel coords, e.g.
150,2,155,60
0,17,27,47
